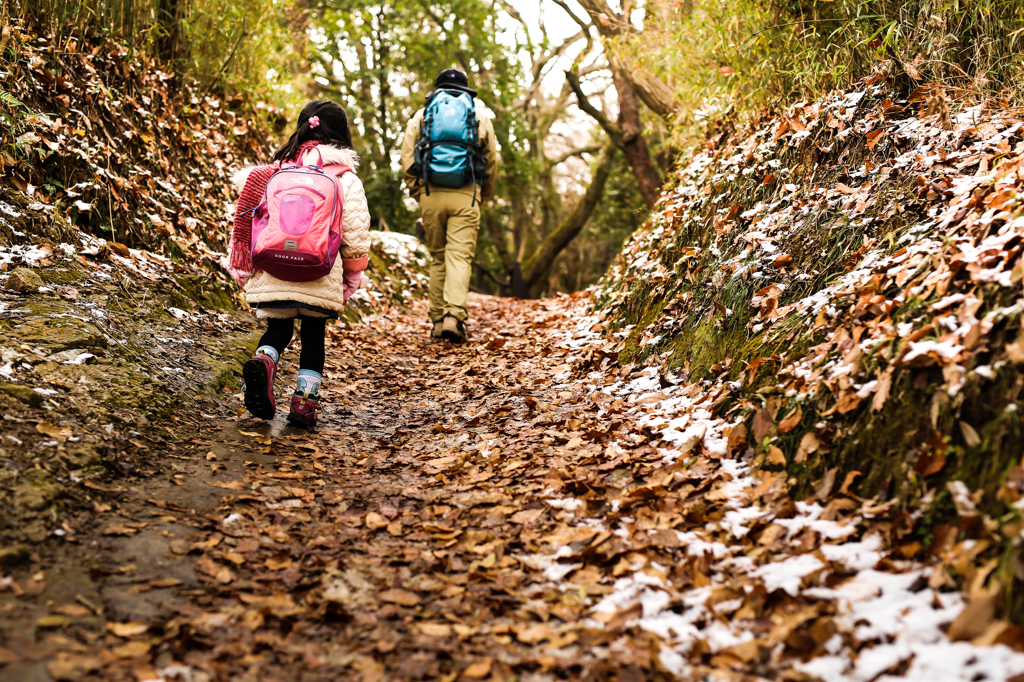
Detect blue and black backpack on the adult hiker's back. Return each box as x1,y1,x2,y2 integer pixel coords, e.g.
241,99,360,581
413,90,486,205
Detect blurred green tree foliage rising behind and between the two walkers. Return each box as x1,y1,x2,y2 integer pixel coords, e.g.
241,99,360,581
310,0,522,232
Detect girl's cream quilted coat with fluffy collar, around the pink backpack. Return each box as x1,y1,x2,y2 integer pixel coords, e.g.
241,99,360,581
232,144,370,316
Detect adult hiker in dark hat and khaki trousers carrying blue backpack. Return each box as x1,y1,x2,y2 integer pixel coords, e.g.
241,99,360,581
401,69,498,343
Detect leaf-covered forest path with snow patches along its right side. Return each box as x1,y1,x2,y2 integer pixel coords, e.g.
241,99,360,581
0,297,1024,682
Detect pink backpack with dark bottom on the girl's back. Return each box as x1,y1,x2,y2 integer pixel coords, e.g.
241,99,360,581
252,147,352,282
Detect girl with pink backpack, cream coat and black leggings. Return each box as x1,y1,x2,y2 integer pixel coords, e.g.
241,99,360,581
229,101,370,426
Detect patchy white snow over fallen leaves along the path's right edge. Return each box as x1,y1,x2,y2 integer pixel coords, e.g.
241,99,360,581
522,296,1024,682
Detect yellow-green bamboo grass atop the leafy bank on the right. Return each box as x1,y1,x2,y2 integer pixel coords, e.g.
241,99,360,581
630,0,1024,143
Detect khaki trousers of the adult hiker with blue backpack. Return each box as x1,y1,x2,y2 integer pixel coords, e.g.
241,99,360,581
420,189,480,322
